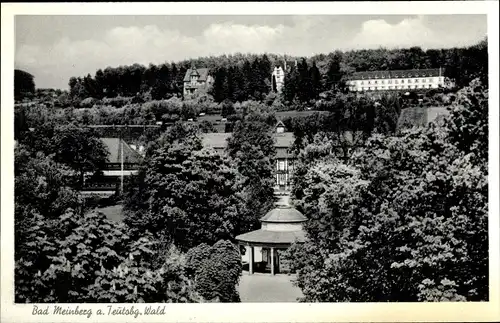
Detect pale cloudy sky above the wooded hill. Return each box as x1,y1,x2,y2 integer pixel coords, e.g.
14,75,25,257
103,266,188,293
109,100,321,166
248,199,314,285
15,15,487,89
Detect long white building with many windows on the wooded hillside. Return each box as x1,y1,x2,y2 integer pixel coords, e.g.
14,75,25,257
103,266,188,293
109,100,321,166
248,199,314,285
347,68,452,92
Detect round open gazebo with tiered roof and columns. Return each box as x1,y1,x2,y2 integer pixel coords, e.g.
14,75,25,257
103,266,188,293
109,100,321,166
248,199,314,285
236,205,307,275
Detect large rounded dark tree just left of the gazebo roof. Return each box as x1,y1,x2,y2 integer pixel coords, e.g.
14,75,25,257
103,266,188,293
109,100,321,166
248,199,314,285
146,144,243,250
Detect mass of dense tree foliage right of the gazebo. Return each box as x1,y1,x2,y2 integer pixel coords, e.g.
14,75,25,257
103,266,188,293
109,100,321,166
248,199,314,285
289,81,488,301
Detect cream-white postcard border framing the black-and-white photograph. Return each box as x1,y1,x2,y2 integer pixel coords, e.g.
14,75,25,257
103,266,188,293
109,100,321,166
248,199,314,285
1,1,500,322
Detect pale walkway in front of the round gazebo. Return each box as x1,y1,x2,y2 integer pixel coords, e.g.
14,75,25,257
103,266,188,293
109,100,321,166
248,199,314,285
238,271,302,303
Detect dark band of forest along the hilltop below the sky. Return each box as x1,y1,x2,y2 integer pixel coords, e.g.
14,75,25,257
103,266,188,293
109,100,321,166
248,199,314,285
63,39,488,102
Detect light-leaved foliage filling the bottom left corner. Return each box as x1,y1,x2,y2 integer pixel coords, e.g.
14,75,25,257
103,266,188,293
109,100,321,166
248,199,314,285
15,211,202,303
